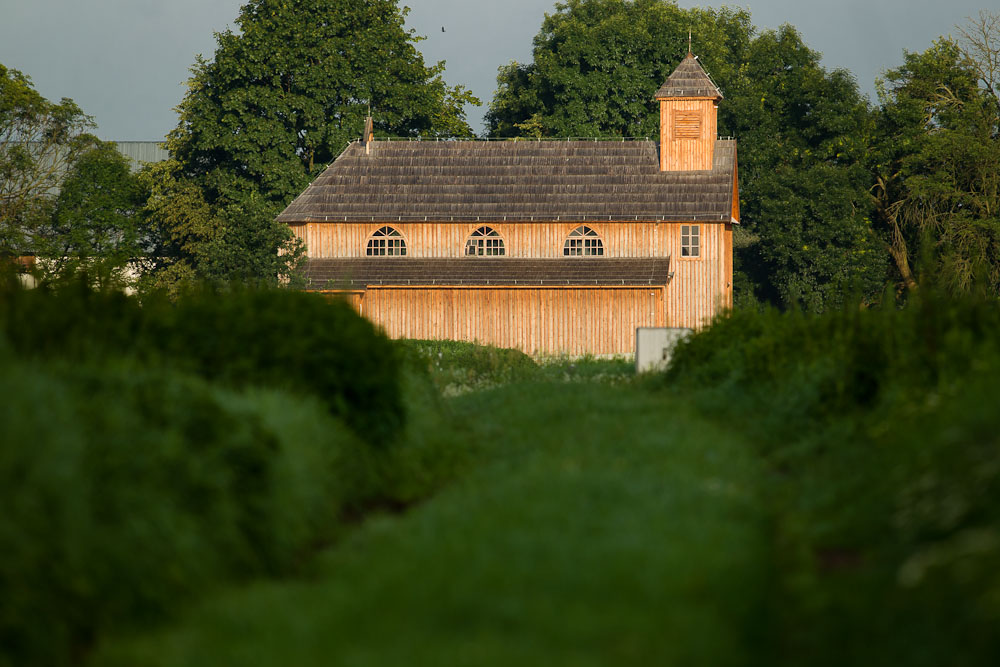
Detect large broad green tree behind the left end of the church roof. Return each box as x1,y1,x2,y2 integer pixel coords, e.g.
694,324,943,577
156,0,478,279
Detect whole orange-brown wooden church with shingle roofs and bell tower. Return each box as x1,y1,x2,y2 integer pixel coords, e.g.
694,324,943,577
278,54,739,355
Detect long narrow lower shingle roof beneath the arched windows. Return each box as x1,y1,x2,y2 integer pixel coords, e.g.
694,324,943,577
303,257,670,289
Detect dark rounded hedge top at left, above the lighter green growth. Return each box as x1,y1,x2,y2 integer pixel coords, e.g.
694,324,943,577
0,285,404,444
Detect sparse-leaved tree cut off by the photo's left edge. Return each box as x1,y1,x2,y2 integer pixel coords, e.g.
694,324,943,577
0,65,94,255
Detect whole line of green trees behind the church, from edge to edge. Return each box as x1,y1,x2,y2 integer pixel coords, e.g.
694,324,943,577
0,0,1000,312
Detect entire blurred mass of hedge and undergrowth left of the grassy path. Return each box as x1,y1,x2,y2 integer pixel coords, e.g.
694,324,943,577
0,285,434,665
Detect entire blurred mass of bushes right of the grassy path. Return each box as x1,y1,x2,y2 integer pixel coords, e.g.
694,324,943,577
665,293,1000,667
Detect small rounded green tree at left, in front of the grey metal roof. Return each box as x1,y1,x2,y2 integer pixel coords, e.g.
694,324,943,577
34,140,145,287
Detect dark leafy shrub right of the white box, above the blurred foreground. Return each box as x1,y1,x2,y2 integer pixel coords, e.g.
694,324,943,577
665,294,1000,439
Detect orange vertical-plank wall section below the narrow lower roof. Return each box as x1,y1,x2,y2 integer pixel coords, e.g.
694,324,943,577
359,286,665,356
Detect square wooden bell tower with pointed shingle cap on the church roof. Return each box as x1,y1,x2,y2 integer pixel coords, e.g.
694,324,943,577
656,51,722,171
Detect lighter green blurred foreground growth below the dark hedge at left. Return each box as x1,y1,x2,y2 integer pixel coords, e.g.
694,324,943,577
0,359,364,665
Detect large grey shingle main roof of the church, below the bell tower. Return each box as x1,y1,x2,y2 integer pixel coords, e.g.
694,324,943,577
278,140,736,223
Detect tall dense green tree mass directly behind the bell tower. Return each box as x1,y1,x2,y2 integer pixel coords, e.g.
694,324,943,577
487,0,885,310
